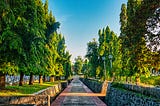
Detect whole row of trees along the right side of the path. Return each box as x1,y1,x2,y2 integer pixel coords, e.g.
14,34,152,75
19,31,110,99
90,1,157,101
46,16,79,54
74,0,160,84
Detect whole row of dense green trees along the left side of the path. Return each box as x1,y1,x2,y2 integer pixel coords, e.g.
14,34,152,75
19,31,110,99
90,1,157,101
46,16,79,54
0,0,71,88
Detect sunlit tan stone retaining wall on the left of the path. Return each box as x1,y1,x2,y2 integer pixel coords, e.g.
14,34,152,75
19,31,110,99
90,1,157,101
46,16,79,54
0,83,61,106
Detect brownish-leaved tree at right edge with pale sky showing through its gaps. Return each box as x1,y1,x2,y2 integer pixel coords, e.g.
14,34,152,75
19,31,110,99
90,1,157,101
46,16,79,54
137,0,160,76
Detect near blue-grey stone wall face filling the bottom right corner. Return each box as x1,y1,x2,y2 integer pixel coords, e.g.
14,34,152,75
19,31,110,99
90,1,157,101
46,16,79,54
105,87,160,106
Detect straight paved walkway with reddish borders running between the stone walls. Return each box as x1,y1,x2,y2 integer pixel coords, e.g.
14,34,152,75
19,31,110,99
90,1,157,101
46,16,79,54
51,78,106,106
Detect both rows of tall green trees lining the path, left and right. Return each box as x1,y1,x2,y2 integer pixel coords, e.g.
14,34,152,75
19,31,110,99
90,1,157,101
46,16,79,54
0,0,160,87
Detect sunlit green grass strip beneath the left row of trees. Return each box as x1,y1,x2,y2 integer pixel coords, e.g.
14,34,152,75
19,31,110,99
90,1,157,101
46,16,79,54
0,82,55,96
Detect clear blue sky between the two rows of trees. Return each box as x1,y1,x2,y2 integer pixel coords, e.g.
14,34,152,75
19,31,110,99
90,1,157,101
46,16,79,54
44,0,127,61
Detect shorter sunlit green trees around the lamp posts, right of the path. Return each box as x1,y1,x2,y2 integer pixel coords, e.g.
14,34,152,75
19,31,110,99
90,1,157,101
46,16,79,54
86,26,122,78
